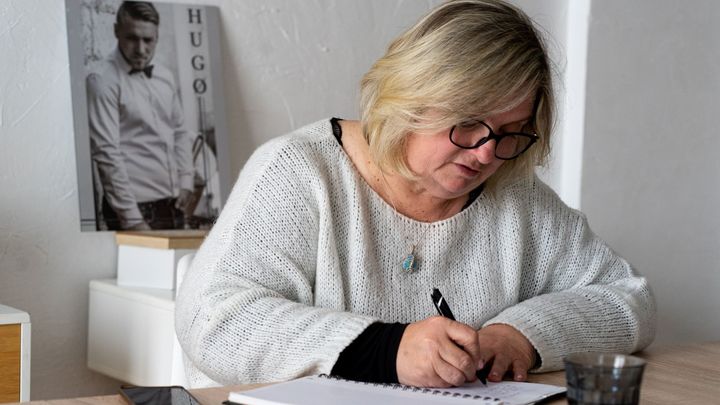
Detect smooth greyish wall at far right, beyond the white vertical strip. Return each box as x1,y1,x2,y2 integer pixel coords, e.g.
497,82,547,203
582,0,720,342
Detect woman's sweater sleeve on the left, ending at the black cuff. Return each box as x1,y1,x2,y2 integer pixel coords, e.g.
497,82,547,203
176,134,376,385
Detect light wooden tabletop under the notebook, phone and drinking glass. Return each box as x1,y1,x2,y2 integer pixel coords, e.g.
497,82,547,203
15,342,720,405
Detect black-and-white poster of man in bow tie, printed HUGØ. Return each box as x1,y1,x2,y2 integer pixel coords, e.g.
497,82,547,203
66,0,229,230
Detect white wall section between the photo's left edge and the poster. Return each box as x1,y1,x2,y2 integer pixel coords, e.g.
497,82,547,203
0,1,122,398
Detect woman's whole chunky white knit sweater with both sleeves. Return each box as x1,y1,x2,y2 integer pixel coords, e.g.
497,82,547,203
176,120,655,386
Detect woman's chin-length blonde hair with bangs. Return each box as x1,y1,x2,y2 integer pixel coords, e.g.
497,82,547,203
360,0,555,190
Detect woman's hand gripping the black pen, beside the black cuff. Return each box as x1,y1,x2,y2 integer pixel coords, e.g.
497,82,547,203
396,316,480,388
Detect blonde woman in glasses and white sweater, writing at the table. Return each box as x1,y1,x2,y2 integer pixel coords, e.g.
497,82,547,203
177,0,655,387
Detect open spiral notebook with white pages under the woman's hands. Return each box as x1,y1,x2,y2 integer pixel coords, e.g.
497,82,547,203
228,374,565,405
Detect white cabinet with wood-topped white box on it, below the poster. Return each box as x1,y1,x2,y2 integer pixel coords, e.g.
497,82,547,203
87,231,207,385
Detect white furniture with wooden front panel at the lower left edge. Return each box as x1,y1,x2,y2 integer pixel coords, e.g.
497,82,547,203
0,305,30,402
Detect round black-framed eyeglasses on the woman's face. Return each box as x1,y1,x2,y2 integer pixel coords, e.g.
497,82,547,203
450,120,540,160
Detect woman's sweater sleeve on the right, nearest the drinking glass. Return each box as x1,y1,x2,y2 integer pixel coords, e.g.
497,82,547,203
484,175,655,371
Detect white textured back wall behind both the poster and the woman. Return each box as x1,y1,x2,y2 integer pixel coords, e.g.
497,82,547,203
0,0,567,399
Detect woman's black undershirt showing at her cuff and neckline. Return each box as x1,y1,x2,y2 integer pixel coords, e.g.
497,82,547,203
330,118,483,383
